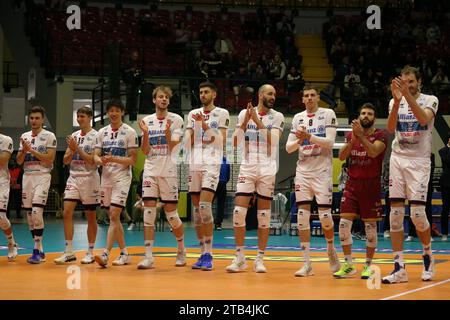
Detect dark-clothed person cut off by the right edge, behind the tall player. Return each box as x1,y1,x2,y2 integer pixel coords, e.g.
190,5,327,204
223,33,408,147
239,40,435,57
439,131,450,241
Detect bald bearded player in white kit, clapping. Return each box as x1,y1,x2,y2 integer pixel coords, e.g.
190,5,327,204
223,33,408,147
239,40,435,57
226,84,284,273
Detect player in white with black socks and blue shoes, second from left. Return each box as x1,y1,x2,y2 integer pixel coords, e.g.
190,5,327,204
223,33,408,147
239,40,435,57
17,106,56,264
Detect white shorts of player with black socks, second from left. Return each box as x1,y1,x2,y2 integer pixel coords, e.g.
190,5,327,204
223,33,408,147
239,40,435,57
22,173,52,210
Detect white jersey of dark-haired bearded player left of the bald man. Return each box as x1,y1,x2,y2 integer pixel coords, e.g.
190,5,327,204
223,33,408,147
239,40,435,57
186,107,230,171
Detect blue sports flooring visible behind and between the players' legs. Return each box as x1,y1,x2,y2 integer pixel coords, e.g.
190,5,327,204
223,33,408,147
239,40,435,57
0,217,450,256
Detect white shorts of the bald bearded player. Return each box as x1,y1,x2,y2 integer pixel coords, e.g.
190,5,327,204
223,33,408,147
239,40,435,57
236,167,276,200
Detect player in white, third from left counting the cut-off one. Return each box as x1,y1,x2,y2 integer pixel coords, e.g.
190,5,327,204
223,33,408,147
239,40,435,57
54,105,100,264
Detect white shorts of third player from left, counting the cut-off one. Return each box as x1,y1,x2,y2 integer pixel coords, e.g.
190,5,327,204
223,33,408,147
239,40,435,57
64,173,100,205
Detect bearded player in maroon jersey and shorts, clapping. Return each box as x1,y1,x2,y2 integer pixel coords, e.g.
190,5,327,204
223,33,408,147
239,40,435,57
333,103,387,279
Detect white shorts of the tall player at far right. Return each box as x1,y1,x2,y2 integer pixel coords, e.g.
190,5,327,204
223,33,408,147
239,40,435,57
389,154,431,204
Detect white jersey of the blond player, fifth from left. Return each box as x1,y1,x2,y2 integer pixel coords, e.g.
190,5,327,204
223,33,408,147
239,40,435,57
143,112,183,177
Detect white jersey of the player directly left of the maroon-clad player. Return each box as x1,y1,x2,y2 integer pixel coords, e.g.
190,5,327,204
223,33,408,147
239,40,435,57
290,108,338,173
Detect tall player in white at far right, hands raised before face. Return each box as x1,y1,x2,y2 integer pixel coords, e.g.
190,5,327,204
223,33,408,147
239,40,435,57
382,66,439,283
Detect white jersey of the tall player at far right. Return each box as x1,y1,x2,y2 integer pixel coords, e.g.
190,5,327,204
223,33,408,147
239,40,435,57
389,93,439,159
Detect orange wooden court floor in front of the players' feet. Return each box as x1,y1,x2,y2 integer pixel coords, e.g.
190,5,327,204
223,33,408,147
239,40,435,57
0,247,450,300
